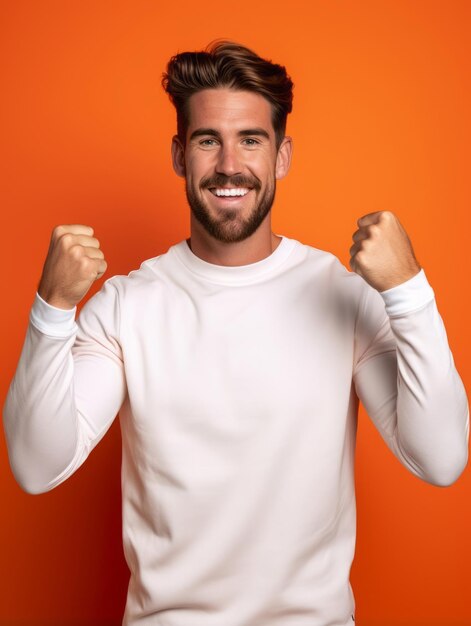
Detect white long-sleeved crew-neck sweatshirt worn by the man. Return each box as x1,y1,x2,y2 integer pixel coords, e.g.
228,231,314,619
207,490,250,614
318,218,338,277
4,237,469,626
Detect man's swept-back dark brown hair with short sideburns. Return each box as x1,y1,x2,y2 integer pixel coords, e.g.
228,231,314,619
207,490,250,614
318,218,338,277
162,40,293,149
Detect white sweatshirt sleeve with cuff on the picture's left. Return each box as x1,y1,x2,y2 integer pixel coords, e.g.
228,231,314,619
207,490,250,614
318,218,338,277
3,281,126,493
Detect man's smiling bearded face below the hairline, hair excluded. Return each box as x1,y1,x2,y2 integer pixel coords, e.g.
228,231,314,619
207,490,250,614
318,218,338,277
173,88,290,243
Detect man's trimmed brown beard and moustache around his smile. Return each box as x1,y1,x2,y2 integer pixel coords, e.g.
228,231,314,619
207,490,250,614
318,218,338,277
185,174,276,243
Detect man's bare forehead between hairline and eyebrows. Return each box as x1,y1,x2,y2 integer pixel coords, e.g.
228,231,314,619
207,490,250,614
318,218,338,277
188,88,274,133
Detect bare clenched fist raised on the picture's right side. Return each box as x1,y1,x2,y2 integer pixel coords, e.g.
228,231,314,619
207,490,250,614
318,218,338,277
350,211,422,291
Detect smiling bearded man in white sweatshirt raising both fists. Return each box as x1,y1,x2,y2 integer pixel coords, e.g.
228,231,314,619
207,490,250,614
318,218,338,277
4,42,469,626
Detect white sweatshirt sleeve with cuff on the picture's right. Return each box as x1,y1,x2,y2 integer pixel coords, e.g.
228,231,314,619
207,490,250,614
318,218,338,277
354,270,469,486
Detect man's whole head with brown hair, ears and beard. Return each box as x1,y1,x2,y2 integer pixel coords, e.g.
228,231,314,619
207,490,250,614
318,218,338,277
162,42,292,243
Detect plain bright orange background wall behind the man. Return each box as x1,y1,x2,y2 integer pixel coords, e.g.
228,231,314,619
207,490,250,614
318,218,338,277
0,0,471,626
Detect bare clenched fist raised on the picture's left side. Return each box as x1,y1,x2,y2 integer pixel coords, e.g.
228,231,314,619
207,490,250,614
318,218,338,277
38,224,107,309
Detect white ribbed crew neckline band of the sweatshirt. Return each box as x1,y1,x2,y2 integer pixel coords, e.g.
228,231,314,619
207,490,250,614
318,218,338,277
172,233,296,285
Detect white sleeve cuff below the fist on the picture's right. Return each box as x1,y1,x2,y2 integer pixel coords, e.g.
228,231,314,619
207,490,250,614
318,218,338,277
379,268,435,317
